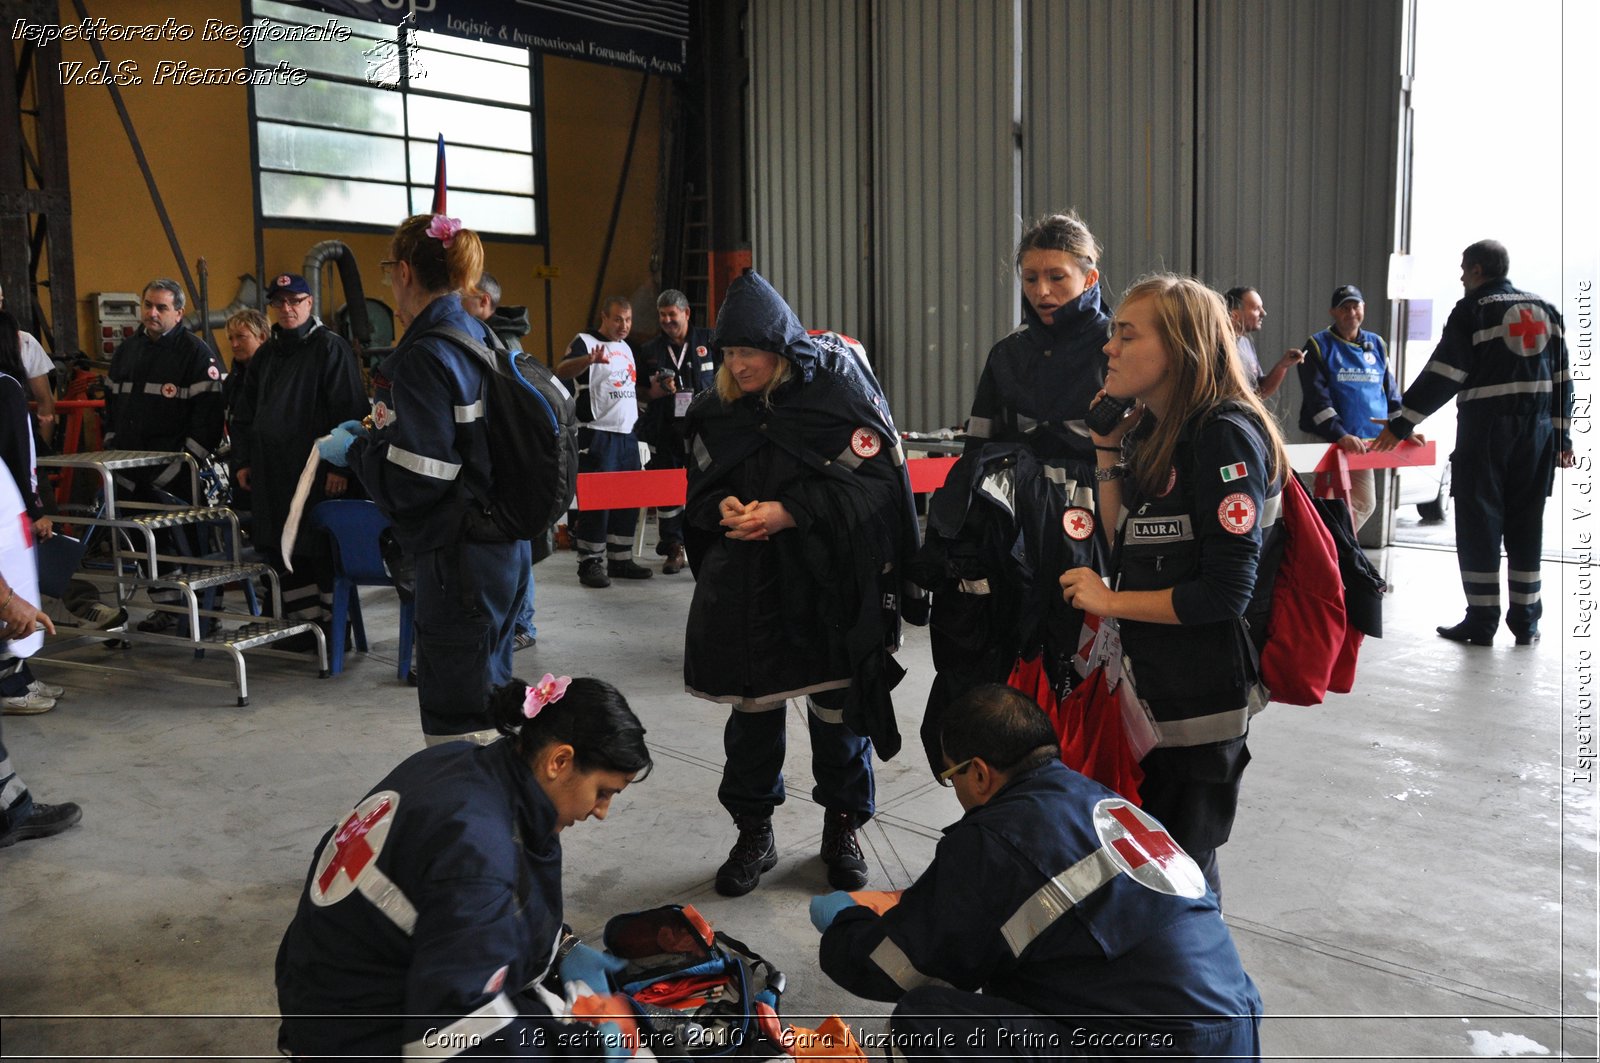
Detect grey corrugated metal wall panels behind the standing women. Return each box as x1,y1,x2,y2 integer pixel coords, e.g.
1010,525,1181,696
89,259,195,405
750,0,1408,435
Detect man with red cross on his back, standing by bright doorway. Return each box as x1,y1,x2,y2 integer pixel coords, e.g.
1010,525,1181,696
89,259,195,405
1373,240,1573,645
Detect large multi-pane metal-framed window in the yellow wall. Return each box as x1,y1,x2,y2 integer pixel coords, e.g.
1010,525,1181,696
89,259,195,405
250,0,542,237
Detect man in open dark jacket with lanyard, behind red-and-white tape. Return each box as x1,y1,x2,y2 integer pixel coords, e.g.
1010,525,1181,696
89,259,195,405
638,288,717,576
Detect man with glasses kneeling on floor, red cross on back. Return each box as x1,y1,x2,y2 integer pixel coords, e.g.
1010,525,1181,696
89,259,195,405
811,685,1261,1060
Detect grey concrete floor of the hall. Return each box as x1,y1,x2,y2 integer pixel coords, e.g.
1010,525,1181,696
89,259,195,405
0,548,1600,1060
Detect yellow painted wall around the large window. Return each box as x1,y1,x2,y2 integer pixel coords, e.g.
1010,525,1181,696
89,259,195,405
61,0,667,368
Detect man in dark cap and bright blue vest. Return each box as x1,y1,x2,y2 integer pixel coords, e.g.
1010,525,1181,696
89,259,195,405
1299,285,1400,532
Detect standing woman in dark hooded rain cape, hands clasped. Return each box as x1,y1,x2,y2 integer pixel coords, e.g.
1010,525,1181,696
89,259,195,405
683,272,917,897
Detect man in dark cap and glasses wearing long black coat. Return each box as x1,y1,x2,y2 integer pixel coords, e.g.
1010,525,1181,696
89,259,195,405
230,274,368,645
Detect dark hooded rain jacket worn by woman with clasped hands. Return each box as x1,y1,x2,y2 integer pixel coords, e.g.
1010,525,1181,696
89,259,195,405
683,274,922,760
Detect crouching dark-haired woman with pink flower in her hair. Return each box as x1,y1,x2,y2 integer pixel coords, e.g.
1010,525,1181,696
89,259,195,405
277,674,651,1058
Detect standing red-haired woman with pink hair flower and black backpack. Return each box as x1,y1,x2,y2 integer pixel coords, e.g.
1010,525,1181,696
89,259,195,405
328,215,533,744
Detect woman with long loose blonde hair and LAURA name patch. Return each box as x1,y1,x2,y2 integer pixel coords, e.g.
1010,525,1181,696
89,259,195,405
1061,274,1288,895
